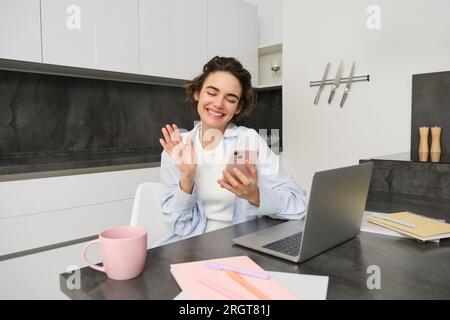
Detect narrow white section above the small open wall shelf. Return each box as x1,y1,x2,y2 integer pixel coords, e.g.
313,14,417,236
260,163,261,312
245,0,283,46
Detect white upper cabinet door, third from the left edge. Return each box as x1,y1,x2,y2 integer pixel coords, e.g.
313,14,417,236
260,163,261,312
139,0,207,79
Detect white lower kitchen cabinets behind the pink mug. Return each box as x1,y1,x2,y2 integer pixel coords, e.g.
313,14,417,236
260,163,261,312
0,167,160,256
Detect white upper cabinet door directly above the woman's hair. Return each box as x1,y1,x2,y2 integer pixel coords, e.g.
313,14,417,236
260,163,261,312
208,0,258,86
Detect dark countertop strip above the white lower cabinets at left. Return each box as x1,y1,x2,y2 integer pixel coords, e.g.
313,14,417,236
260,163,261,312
0,148,162,176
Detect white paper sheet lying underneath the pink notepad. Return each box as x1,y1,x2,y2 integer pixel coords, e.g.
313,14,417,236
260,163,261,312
174,271,328,300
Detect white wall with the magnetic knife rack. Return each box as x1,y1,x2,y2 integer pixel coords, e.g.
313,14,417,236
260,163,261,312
283,0,450,190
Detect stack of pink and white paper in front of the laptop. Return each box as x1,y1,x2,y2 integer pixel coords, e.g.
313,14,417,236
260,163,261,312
170,256,328,300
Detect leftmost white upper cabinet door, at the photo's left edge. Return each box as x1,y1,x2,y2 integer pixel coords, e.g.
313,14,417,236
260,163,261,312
0,0,42,62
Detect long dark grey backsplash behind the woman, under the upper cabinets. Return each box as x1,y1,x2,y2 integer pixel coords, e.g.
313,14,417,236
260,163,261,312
0,70,282,158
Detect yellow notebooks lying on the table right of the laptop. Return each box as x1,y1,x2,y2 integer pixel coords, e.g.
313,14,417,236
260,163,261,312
368,211,450,241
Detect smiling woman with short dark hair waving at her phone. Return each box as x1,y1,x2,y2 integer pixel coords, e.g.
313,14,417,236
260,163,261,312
156,57,306,243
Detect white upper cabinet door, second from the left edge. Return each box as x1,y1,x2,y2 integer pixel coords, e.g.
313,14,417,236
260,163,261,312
41,0,139,73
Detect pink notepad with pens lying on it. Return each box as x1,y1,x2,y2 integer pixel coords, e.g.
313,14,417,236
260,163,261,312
170,256,297,300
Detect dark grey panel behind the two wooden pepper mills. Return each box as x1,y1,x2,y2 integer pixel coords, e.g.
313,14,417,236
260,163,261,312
411,71,450,163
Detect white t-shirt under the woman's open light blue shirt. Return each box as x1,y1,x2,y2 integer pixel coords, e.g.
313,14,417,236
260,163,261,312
194,128,236,232
